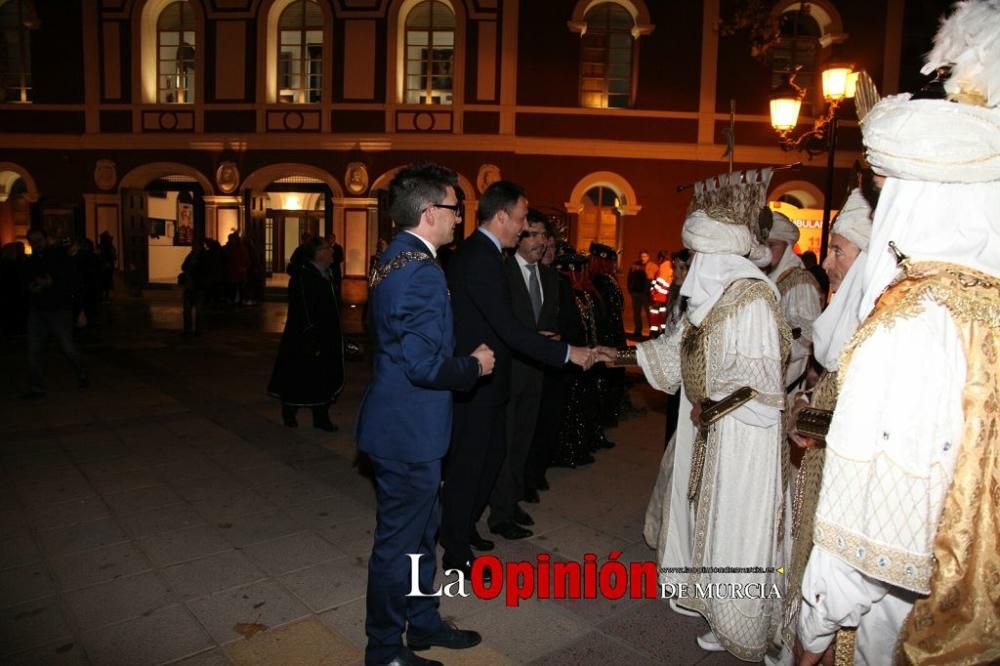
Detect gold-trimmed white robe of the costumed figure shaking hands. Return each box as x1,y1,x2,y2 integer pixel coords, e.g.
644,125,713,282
637,279,790,661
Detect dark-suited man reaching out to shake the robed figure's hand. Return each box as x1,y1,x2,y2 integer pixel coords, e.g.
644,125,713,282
440,181,594,571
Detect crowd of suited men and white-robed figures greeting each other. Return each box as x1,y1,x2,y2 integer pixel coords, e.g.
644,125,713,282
348,2,1000,665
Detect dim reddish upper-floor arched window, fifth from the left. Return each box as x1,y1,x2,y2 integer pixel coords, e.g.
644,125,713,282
580,2,636,109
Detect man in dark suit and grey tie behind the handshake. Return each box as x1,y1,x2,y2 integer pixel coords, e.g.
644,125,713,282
490,209,559,545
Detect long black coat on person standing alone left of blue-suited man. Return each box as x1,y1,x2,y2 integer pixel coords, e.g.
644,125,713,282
267,262,344,407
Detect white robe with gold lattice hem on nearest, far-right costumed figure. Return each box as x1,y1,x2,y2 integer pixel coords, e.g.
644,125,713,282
798,302,966,664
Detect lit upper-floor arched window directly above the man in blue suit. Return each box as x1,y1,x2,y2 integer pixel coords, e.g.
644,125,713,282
404,0,455,104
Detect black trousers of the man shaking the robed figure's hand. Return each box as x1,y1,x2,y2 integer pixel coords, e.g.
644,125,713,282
441,403,507,564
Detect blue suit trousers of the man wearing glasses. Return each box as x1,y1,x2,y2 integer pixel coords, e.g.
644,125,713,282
365,456,441,664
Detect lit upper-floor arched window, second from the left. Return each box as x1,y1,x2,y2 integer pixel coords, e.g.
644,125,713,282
156,0,197,104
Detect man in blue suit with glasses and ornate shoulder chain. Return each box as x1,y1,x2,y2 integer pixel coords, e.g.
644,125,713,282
355,164,494,666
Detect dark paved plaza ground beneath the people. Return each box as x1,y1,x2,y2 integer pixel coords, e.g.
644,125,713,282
0,291,741,666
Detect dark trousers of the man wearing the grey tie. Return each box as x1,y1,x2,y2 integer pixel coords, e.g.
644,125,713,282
489,372,542,527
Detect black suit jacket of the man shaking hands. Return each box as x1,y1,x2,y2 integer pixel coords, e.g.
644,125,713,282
448,230,566,405
